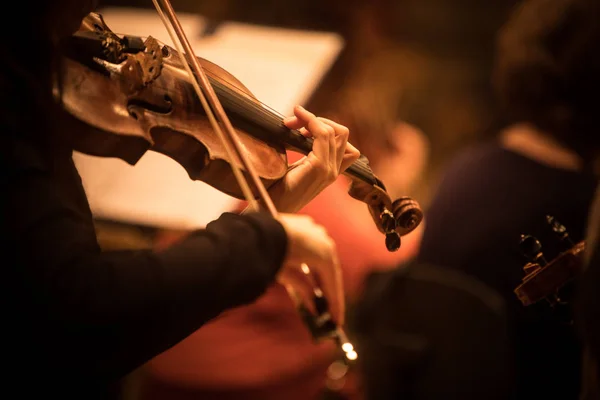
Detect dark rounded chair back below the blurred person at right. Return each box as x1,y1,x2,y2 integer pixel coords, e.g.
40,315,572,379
352,263,510,400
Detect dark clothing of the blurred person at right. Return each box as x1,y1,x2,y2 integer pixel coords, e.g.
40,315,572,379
418,143,598,400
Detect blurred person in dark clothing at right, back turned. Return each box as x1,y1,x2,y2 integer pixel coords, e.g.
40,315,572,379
418,0,600,399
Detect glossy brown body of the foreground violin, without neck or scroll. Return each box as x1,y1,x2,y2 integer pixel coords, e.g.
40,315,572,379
62,13,287,199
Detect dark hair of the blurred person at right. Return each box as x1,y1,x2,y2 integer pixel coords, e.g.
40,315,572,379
493,0,600,156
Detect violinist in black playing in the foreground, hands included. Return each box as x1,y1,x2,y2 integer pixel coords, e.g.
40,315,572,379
0,0,358,399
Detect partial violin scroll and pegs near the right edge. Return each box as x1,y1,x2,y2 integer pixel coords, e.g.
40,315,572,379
514,216,585,307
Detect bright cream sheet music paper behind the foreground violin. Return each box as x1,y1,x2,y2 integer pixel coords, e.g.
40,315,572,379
74,7,343,229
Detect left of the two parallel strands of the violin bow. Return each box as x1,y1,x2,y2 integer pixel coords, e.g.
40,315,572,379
152,0,259,210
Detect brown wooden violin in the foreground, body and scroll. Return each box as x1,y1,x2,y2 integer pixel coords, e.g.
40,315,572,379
58,13,423,251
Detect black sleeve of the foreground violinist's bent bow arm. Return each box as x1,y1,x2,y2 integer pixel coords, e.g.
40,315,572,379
4,165,287,381
